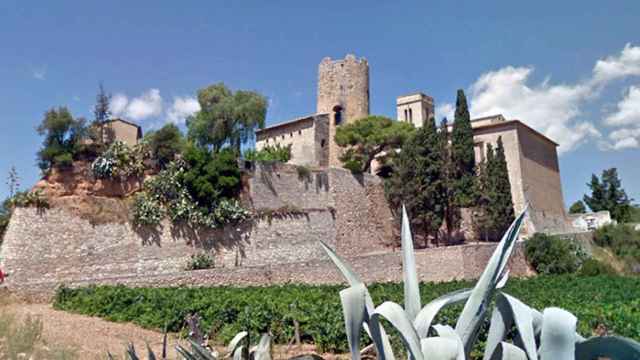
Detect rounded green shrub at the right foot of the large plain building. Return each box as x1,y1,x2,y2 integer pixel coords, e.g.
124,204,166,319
525,233,586,274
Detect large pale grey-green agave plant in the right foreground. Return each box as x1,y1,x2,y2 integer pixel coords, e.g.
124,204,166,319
322,207,640,360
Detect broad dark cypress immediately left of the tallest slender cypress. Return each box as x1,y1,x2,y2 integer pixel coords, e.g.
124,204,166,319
386,118,444,245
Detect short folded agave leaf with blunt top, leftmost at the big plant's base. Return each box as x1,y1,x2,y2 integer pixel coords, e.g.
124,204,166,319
340,284,366,360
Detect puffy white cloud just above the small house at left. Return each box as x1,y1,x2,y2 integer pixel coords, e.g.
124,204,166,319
111,89,163,121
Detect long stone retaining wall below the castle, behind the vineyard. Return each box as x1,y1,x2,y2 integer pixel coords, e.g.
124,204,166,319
0,164,530,295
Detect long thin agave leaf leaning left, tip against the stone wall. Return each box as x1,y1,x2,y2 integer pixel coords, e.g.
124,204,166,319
320,241,395,360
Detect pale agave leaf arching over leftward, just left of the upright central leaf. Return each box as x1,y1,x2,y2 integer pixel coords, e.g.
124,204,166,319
370,301,423,360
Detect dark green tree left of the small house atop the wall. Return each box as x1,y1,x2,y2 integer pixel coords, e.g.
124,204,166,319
37,107,87,171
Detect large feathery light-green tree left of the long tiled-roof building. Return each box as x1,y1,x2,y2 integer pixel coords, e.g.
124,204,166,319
187,83,267,154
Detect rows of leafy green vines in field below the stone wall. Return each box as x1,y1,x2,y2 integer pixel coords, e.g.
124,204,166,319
54,275,640,352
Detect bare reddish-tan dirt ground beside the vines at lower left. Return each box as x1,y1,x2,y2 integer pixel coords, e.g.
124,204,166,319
0,304,176,359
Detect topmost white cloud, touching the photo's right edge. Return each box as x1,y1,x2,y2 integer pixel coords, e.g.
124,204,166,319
593,44,640,84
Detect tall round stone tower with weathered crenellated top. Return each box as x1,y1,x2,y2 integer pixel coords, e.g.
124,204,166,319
317,55,369,166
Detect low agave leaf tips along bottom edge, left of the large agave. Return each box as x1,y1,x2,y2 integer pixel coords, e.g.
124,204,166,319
114,331,271,360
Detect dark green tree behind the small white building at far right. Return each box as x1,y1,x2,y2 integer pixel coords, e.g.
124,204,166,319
583,168,632,222
